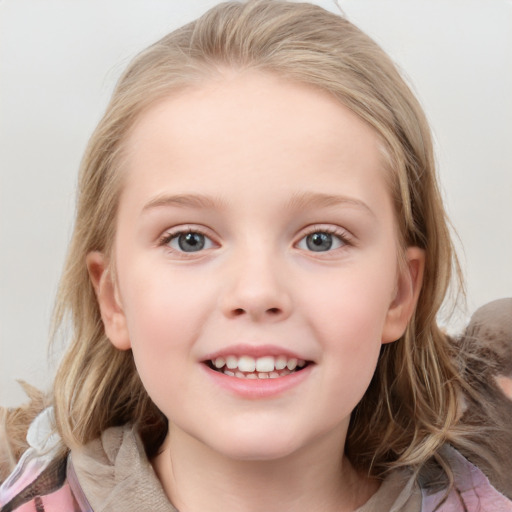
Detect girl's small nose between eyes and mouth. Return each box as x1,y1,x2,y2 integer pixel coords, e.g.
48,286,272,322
222,248,292,322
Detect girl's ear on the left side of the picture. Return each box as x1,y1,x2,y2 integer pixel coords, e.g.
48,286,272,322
86,251,131,350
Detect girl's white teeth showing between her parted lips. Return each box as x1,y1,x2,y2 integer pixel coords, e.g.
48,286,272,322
205,355,311,379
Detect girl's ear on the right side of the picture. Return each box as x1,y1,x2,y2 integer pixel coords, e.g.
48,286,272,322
382,247,425,343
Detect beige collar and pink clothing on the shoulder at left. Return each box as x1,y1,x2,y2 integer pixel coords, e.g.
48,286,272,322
0,425,177,512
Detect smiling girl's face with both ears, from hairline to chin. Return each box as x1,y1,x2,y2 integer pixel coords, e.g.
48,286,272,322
88,72,423,460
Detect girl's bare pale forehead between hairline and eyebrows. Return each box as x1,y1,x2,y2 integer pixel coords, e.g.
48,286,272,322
120,71,385,212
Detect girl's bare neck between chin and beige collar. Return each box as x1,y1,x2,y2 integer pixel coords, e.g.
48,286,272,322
153,429,379,512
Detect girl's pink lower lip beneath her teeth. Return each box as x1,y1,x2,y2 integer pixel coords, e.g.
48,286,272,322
202,364,314,400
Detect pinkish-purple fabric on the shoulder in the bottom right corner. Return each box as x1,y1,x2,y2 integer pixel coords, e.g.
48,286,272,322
422,446,512,512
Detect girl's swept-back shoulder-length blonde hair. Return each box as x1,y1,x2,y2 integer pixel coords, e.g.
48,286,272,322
54,0,496,484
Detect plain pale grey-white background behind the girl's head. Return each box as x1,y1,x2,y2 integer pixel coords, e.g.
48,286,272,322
0,0,512,405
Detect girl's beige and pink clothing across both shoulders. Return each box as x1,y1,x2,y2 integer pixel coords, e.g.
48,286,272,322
0,422,512,512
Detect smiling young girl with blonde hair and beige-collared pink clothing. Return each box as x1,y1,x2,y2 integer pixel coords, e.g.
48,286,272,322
0,0,512,512
